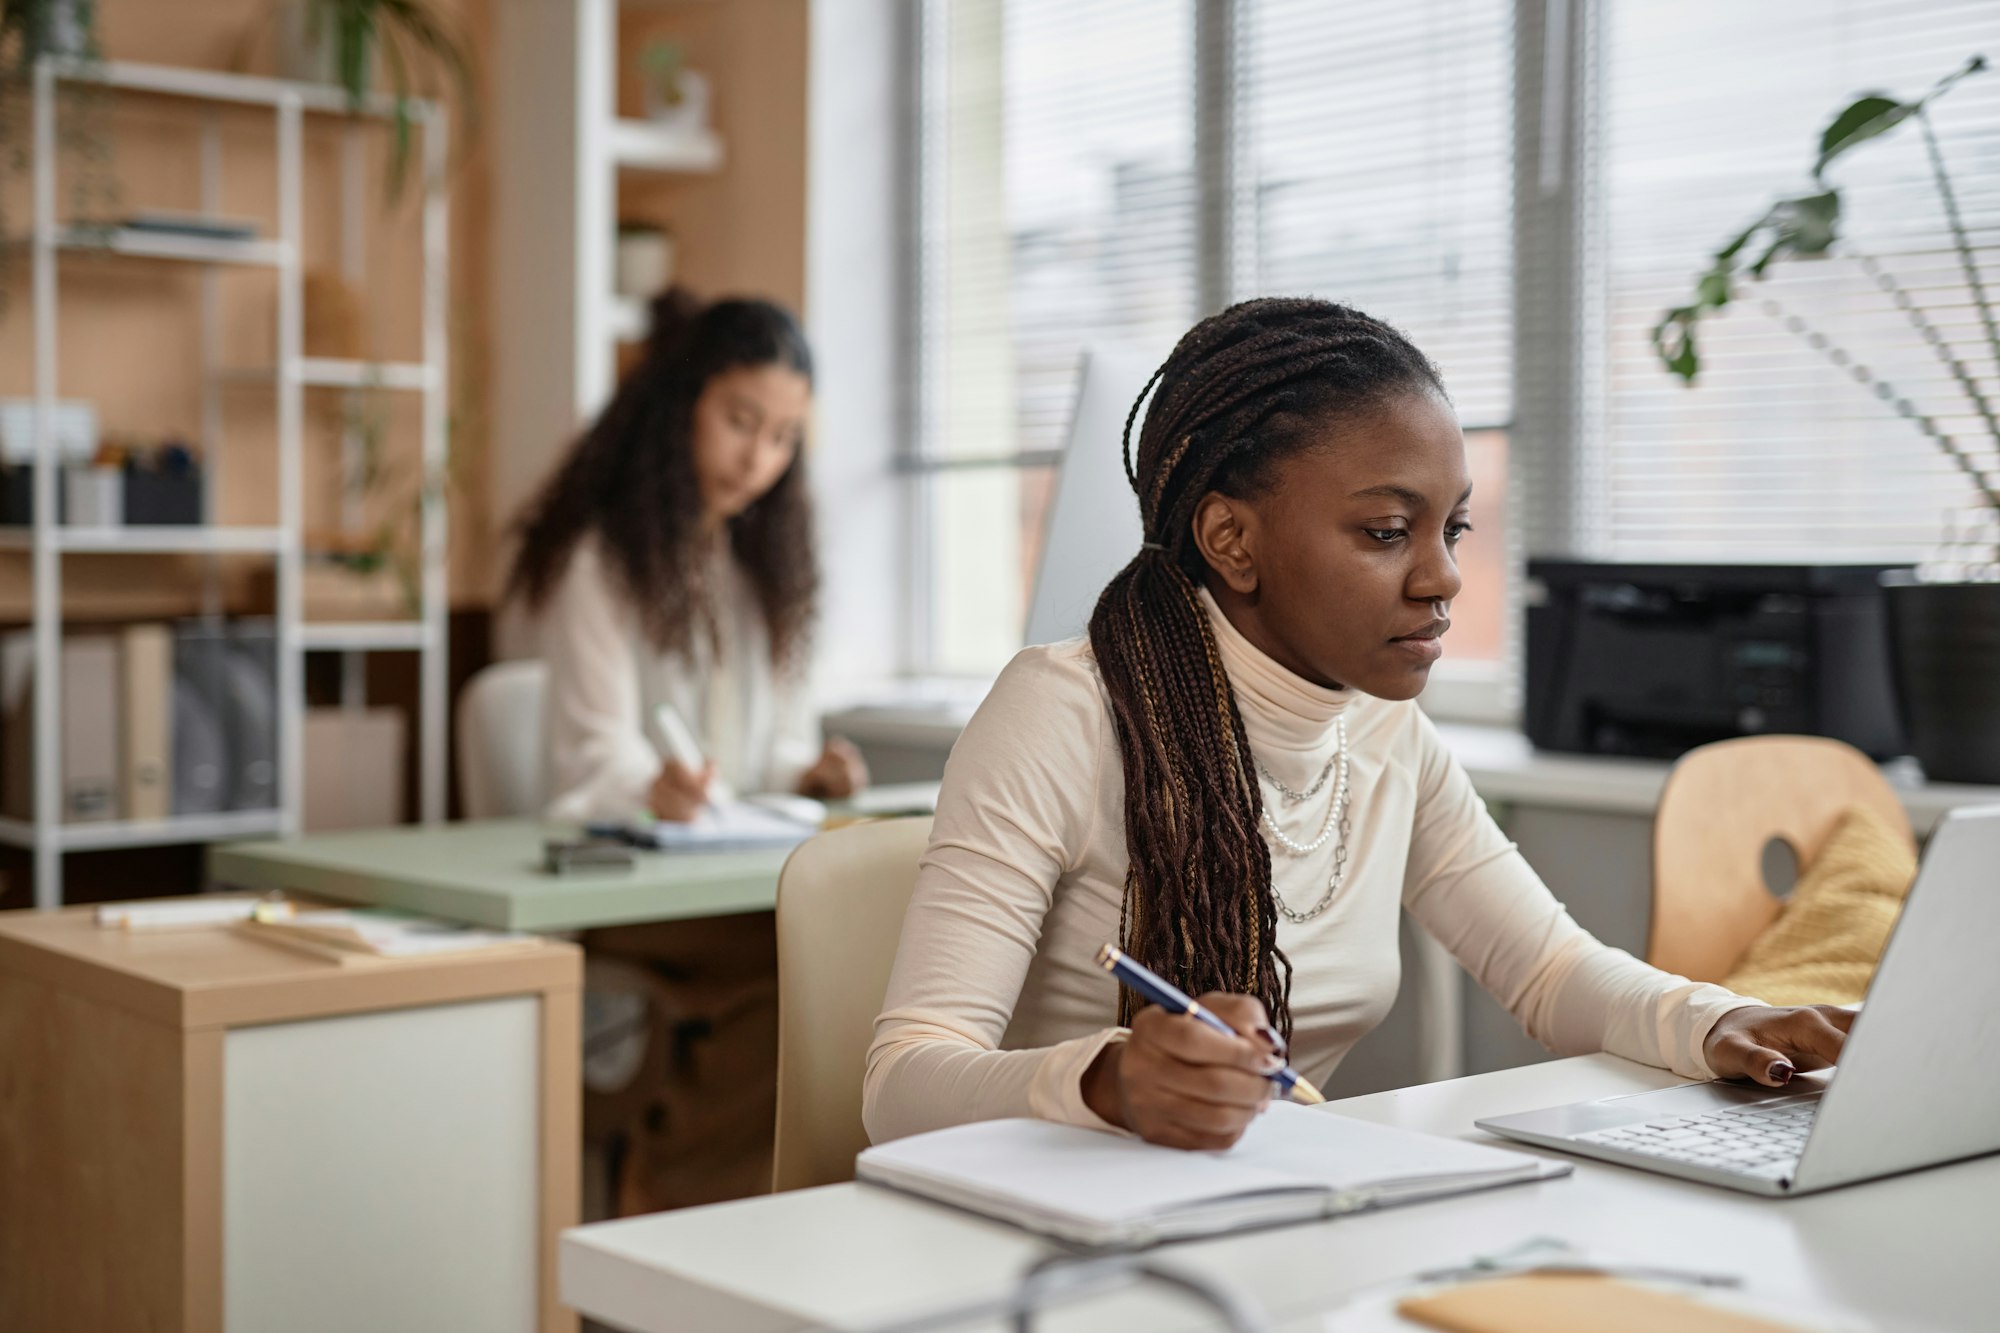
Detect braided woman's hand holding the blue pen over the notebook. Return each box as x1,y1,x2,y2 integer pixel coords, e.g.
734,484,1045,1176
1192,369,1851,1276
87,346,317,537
1082,993,1284,1153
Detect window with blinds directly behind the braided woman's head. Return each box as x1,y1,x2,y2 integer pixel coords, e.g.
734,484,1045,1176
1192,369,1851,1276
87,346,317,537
906,0,1512,675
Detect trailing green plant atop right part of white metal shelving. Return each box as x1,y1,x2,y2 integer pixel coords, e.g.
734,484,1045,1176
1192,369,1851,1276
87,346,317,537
280,0,478,198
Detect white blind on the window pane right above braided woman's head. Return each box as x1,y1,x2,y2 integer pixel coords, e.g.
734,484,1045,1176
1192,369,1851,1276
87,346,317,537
1234,0,1514,426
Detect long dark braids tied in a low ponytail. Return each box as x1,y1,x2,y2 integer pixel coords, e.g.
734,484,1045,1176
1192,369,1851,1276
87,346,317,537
1090,298,1444,1039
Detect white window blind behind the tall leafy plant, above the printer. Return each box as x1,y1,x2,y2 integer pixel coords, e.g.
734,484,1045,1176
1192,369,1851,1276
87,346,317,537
1576,0,2000,560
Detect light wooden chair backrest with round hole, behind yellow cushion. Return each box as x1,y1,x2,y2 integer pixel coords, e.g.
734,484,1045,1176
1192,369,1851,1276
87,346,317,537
1646,737,1916,981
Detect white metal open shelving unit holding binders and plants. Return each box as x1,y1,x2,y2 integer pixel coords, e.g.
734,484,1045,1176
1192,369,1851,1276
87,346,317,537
16,60,450,909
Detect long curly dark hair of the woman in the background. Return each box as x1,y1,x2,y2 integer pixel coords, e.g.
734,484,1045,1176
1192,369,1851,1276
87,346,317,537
508,286,820,667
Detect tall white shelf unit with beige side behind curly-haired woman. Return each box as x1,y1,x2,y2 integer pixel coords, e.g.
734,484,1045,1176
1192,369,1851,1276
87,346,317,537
490,0,726,548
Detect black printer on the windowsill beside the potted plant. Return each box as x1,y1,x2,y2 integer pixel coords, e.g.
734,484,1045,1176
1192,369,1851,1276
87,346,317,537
1526,560,1904,759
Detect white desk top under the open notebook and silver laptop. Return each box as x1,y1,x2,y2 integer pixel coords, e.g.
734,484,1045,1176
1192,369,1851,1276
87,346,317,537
560,1055,2000,1333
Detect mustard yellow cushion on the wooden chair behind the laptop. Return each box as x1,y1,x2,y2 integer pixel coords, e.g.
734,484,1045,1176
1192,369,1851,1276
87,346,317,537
1722,792,1916,1005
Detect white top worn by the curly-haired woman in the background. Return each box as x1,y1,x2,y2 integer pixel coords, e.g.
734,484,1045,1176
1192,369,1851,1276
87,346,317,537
540,536,820,821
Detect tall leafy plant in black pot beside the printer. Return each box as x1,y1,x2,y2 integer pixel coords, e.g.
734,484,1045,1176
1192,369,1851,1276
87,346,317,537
1652,56,2000,783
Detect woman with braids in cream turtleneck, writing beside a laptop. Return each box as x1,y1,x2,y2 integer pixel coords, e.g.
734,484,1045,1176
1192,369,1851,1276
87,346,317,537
864,300,1848,1149
